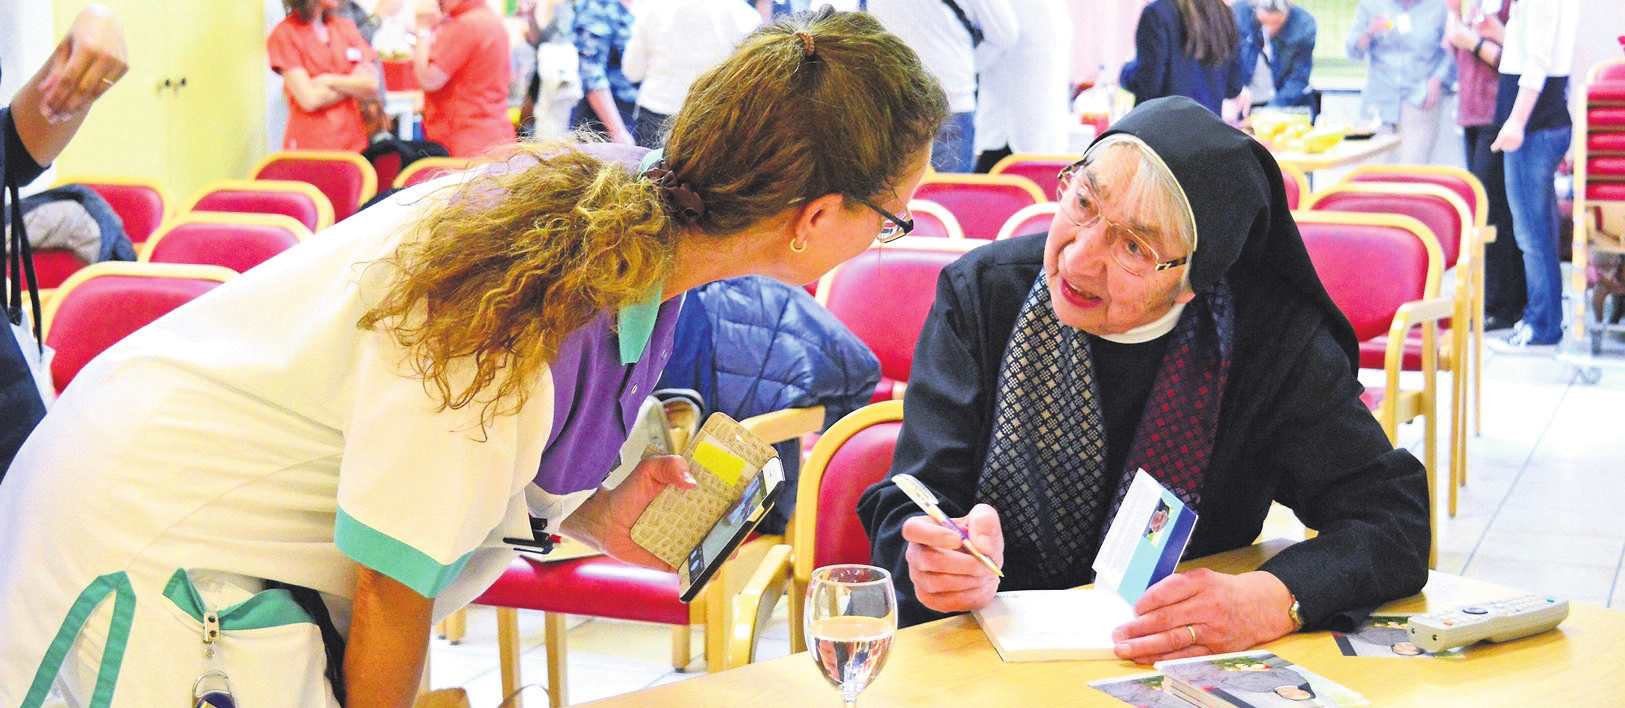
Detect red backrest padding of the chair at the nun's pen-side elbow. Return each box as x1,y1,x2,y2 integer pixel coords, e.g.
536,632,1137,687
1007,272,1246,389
813,421,904,567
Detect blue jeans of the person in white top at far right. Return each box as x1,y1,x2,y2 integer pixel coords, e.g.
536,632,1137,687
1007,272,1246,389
1503,125,1571,344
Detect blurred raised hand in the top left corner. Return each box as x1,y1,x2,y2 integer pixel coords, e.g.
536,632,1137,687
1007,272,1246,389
39,5,130,122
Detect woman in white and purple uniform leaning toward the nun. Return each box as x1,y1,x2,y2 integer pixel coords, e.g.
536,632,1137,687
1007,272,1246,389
0,11,946,708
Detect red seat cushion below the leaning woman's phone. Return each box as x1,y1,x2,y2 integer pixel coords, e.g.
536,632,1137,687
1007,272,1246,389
475,555,689,625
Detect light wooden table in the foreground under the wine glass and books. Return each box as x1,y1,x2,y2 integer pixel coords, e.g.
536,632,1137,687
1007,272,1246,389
590,539,1625,708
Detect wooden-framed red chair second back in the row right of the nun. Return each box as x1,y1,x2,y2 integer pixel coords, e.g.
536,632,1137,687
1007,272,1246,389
1305,182,1484,515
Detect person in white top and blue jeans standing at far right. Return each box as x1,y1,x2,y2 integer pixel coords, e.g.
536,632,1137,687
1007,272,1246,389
1490,0,1580,352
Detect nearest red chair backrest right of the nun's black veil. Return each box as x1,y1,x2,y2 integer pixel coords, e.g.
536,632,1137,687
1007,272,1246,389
1294,211,1443,341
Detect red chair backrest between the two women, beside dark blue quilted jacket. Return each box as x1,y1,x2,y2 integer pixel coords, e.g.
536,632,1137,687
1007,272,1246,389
817,235,983,401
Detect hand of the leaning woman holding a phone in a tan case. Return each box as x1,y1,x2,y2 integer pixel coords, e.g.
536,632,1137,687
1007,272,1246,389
559,455,694,570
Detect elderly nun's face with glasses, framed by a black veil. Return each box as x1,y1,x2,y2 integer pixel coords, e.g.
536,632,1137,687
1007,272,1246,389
1043,151,1194,336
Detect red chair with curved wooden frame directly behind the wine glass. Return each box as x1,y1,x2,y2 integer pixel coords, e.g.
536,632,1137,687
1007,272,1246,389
728,401,904,667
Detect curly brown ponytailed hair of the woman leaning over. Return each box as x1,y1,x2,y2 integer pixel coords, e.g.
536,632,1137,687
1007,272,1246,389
358,8,947,424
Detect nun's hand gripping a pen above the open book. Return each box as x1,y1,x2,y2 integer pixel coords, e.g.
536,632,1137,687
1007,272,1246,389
904,503,1004,612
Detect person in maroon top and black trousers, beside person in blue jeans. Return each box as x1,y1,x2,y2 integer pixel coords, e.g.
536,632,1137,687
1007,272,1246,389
1445,0,1529,331
